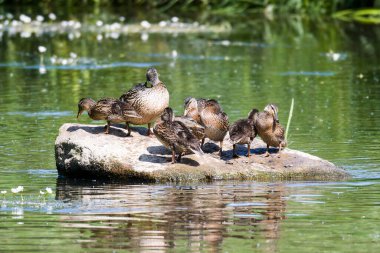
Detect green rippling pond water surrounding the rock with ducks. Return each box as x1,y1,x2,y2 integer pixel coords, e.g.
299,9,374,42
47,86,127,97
0,12,380,252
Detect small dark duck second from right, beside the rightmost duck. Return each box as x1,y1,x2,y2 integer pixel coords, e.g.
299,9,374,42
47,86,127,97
229,109,259,158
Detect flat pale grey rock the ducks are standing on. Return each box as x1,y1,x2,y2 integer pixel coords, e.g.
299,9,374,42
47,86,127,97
55,124,350,182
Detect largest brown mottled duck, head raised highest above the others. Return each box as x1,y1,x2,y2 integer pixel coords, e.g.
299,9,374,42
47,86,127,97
120,68,169,136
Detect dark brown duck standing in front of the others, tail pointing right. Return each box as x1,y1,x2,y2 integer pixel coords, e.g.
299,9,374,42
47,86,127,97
153,107,203,163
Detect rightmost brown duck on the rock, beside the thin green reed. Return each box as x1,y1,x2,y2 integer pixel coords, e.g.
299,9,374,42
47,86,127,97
255,104,287,157
